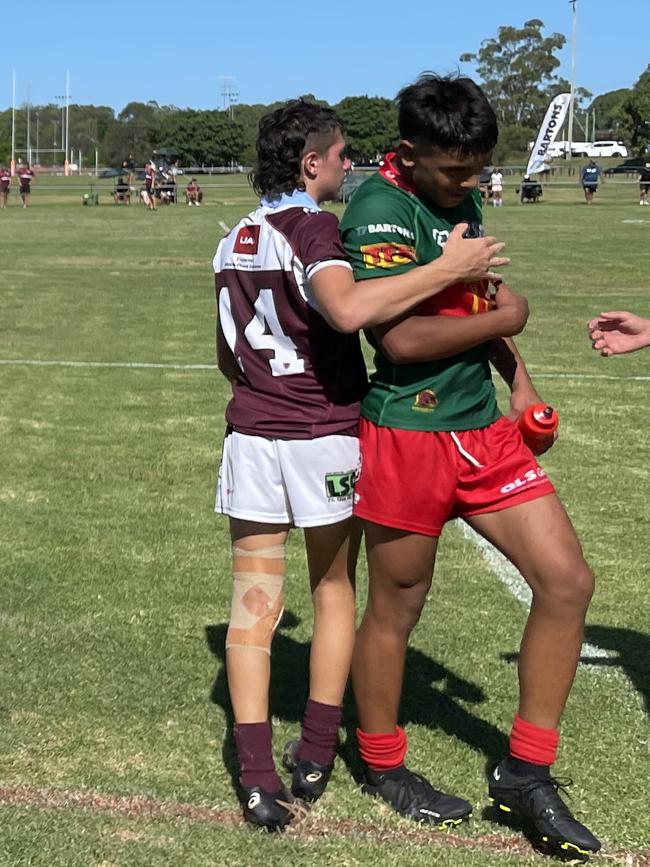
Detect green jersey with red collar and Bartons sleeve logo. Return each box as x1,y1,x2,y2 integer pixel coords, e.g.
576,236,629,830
340,154,501,431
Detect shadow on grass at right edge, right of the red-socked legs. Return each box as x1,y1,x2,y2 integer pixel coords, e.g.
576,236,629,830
501,625,650,712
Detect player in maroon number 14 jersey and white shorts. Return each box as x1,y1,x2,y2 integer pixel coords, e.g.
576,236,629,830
214,100,513,830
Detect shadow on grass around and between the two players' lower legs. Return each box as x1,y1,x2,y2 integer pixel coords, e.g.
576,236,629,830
205,611,507,786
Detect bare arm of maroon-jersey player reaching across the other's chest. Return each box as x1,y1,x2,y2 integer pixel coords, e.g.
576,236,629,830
311,223,510,333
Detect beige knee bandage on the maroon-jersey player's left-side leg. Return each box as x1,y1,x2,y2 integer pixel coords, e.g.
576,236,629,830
226,545,284,654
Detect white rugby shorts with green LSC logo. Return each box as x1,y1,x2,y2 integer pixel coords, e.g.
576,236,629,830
214,431,359,527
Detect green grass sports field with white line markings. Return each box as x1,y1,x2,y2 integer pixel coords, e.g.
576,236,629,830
0,177,650,867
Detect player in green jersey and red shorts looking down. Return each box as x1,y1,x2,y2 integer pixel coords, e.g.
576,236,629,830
341,74,600,854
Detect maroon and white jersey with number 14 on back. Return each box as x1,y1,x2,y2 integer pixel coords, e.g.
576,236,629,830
214,192,366,439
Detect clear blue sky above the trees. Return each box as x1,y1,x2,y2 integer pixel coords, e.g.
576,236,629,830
6,0,650,110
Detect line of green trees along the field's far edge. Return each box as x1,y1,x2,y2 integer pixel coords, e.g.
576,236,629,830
0,19,650,166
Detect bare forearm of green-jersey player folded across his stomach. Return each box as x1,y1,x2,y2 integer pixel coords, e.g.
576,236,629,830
373,284,528,364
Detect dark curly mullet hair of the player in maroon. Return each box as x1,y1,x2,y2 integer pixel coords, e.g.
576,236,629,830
249,99,343,196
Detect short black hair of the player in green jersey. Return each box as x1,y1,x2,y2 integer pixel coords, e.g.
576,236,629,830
396,72,499,157
